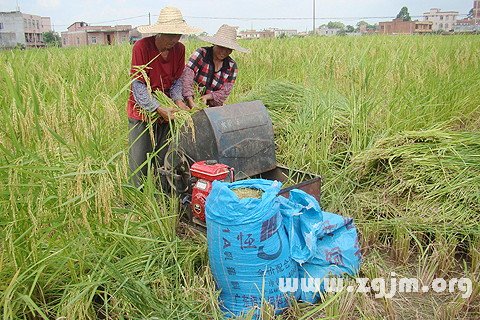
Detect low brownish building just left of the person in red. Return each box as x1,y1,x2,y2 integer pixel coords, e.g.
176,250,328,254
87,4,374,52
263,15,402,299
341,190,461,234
62,22,132,47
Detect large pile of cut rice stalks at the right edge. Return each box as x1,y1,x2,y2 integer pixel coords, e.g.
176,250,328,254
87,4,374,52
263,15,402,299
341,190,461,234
349,130,480,236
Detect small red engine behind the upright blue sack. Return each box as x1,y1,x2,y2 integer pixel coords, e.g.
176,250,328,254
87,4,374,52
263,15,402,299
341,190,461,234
190,160,234,222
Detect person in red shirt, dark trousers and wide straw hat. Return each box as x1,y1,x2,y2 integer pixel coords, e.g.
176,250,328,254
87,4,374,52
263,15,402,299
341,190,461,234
127,7,200,187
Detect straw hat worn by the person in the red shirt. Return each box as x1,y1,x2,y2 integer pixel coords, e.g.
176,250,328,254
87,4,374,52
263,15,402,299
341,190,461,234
137,7,201,34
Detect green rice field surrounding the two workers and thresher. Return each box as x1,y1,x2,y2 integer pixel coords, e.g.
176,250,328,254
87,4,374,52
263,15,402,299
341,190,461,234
0,36,480,319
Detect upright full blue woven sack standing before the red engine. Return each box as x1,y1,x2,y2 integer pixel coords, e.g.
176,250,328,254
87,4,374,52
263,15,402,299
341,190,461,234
206,179,298,316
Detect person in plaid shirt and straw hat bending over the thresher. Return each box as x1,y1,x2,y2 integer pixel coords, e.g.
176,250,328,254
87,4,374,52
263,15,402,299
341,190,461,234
176,24,249,107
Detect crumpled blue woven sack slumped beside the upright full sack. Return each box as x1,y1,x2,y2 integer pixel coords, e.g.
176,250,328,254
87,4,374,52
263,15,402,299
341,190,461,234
279,189,361,303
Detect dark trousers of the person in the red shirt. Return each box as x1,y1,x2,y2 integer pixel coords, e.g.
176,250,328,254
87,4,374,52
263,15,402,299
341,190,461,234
128,118,170,187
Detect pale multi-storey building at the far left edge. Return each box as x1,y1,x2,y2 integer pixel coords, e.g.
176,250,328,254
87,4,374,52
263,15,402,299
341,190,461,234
0,11,52,48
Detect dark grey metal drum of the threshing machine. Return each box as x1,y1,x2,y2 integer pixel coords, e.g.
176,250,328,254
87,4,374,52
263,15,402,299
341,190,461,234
170,101,277,180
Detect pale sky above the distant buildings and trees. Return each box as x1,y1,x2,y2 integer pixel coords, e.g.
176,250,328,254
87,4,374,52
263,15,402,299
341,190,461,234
0,0,473,34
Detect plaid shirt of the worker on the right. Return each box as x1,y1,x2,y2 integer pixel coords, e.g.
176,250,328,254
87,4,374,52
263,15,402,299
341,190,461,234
183,47,238,96
